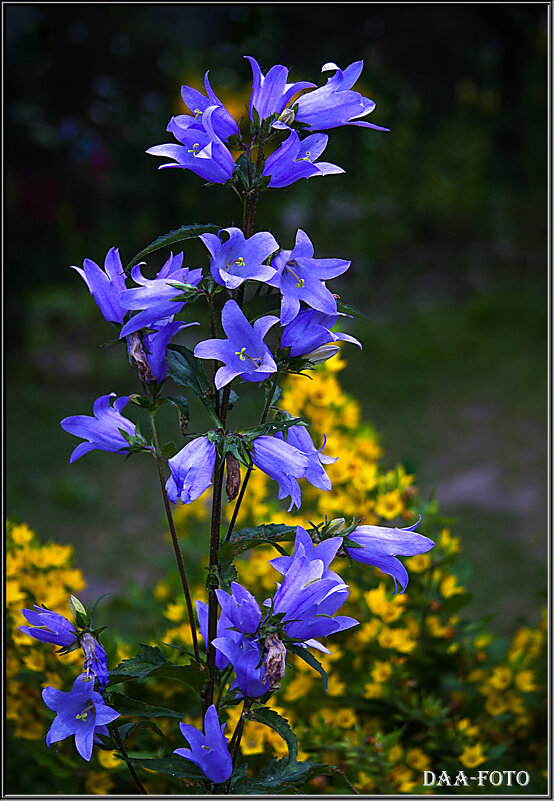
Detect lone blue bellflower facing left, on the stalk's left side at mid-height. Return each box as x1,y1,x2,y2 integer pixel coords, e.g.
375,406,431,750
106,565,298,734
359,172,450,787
60,392,137,462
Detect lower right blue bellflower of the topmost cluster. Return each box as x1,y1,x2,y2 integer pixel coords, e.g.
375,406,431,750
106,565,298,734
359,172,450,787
262,131,344,189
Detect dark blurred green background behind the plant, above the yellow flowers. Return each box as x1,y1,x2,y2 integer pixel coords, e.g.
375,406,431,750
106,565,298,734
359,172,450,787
5,3,548,633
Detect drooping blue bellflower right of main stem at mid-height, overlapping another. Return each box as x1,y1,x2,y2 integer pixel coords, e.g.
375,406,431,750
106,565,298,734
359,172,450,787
252,436,310,512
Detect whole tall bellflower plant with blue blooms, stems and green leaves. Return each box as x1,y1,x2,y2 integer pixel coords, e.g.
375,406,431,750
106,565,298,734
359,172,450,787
21,56,433,794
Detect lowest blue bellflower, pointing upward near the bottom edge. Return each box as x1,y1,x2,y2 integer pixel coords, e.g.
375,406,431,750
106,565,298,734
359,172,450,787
173,704,233,784
